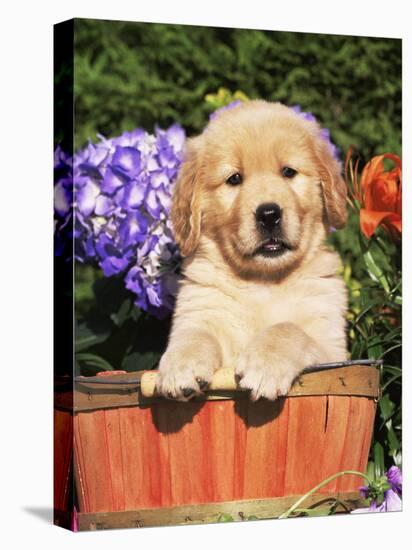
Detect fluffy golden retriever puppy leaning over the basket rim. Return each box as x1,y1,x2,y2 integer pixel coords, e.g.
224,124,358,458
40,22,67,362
157,101,346,400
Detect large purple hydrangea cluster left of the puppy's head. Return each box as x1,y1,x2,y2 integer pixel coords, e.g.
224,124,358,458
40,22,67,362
54,124,186,318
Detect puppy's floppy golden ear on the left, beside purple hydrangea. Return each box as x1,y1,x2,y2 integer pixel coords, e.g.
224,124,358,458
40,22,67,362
170,138,201,256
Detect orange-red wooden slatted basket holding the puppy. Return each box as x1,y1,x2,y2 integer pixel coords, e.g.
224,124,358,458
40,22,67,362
54,364,379,530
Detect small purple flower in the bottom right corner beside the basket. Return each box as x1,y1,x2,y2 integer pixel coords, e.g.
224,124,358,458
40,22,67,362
352,466,402,514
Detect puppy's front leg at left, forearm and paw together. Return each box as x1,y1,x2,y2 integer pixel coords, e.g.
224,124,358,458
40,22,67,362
156,328,221,401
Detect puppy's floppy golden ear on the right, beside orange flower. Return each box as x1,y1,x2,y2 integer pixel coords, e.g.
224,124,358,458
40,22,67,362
316,139,348,229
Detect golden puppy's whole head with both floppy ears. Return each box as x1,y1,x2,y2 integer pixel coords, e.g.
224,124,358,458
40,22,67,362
171,101,346,277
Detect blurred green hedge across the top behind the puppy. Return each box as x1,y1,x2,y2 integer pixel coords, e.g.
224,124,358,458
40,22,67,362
75,19,401,157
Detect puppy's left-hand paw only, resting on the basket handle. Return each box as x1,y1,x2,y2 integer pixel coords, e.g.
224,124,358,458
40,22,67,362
156,352,215,401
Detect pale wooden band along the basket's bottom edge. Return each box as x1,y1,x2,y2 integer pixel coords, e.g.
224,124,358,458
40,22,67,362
78,492,363,531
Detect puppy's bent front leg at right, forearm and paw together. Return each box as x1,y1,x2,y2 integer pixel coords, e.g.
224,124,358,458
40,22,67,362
236,323,327,401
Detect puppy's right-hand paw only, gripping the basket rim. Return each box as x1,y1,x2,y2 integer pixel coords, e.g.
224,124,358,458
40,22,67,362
235,349,301,401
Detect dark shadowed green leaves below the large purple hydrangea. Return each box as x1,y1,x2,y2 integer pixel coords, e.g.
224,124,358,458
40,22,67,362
75,274,170,376
